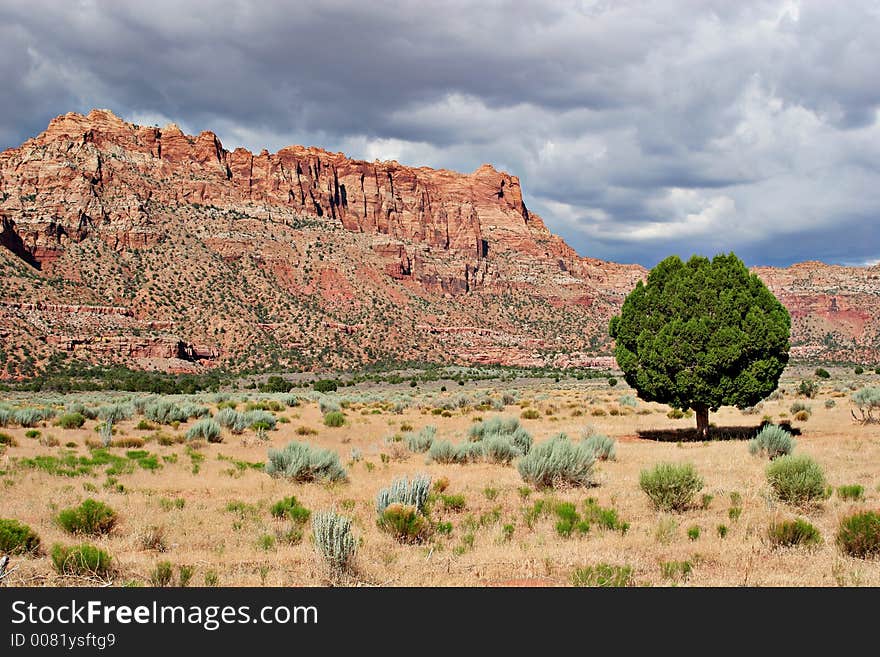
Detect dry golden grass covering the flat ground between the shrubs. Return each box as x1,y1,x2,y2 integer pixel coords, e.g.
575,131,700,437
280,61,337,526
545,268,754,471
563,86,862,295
0,381,880,586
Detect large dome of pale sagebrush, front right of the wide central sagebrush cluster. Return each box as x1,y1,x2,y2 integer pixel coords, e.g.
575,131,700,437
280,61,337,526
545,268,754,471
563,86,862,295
517,433,596,488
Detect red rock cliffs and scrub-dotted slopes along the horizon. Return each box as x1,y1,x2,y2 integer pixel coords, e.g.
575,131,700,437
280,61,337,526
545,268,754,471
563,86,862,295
0,110,880,376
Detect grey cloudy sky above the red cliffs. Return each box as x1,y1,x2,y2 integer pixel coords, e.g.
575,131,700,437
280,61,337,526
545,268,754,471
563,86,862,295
0,0,880,266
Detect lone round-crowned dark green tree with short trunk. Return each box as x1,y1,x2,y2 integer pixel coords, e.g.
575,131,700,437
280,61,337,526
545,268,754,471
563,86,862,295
609,253,791,438
